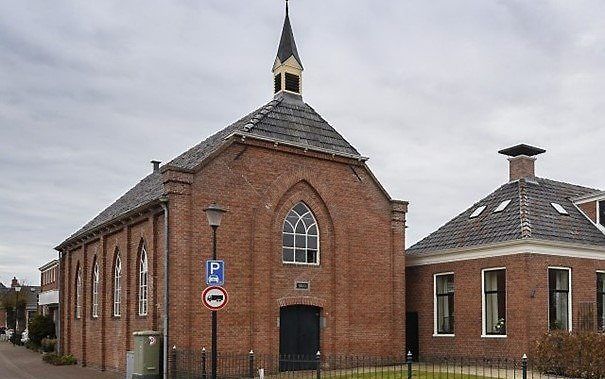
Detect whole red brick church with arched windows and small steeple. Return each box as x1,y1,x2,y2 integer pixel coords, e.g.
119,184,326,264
56,3,407,370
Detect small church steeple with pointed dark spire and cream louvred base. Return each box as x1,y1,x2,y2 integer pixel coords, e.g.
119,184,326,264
273,0,303,95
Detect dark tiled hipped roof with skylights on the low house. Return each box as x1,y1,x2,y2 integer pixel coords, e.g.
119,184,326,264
407,178,605,255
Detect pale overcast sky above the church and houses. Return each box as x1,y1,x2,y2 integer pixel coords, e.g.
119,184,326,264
0,0,605,284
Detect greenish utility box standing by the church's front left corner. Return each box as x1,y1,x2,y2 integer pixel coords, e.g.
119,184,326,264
132,330,162,379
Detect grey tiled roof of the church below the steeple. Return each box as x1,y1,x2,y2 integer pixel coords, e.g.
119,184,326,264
57,93,358,244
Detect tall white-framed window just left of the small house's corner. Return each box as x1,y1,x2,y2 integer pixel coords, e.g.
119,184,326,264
483,269,506,336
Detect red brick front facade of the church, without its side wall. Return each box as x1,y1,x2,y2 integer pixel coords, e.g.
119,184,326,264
164,140,404,360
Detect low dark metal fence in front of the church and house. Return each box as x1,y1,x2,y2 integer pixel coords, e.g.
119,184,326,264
170,350,605,379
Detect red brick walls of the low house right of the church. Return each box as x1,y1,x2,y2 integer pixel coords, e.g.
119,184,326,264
406,254,605,359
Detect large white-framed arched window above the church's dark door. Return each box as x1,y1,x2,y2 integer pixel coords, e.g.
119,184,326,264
282,202,319,265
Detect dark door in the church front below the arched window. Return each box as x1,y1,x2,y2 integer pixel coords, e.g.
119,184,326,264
279,305,320,371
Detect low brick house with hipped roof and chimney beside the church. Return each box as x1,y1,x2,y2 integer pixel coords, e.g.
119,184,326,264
406,145,605,358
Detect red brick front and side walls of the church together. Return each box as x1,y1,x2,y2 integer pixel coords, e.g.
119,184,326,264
61,141,406,370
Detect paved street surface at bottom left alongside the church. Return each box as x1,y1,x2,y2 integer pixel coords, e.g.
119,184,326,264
0,342,124,379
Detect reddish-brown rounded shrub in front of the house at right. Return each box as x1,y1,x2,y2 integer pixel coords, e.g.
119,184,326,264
531,331,605,379
